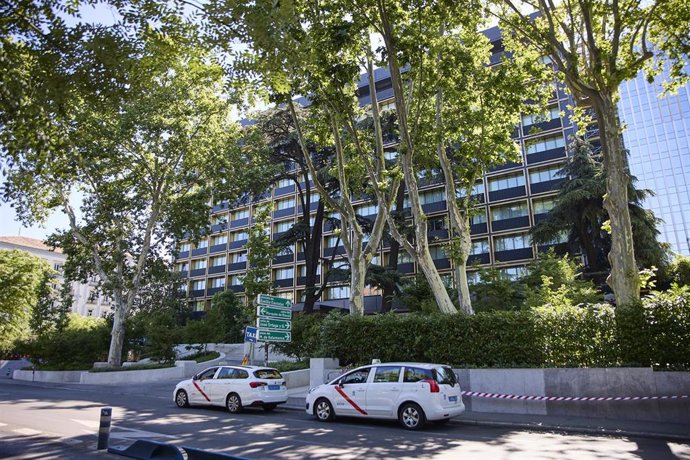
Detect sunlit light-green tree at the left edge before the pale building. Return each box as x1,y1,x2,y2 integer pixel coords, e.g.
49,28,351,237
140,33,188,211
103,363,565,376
0,249,52,350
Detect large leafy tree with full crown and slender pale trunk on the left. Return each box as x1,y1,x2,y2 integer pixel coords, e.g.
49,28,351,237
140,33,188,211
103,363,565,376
0,26,255,366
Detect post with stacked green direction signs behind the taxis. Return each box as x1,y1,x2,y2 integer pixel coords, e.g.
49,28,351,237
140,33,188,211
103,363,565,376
256,294,292,365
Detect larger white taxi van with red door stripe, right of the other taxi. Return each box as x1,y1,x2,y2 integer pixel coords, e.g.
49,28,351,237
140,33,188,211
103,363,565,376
306,363,465,430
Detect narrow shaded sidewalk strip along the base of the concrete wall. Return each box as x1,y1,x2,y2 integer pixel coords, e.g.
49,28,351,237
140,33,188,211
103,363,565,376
281,387,690,443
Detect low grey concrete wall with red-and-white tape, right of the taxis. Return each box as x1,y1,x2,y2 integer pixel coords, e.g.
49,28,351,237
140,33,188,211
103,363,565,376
455,368,690,424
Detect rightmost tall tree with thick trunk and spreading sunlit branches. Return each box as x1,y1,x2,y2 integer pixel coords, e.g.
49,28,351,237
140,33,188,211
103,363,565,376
496,0,690,305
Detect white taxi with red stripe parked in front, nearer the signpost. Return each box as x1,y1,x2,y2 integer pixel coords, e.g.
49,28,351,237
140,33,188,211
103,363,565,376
173,366,287,414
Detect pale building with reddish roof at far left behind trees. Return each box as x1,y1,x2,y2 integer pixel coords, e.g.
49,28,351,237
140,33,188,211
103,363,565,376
0,236,111,317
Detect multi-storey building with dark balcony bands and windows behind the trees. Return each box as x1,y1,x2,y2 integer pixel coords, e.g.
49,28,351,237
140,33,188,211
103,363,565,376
176,28,575,312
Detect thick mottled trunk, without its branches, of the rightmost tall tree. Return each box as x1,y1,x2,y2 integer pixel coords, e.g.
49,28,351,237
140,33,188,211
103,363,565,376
592,91,640,305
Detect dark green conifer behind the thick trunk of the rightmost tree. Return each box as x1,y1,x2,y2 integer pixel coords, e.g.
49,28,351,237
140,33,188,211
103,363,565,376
532,138,668,273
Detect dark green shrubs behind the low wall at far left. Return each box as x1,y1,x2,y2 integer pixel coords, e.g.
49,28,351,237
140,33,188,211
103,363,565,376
18,314,111,370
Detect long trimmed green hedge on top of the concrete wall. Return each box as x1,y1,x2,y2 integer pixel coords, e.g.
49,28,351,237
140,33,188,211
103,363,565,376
277,290,690,369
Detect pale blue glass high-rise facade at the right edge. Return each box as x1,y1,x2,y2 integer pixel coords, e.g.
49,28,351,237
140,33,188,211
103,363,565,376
618,68,690,256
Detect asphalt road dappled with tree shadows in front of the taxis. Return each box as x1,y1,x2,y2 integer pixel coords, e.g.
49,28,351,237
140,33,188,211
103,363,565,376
0,380,690,460
